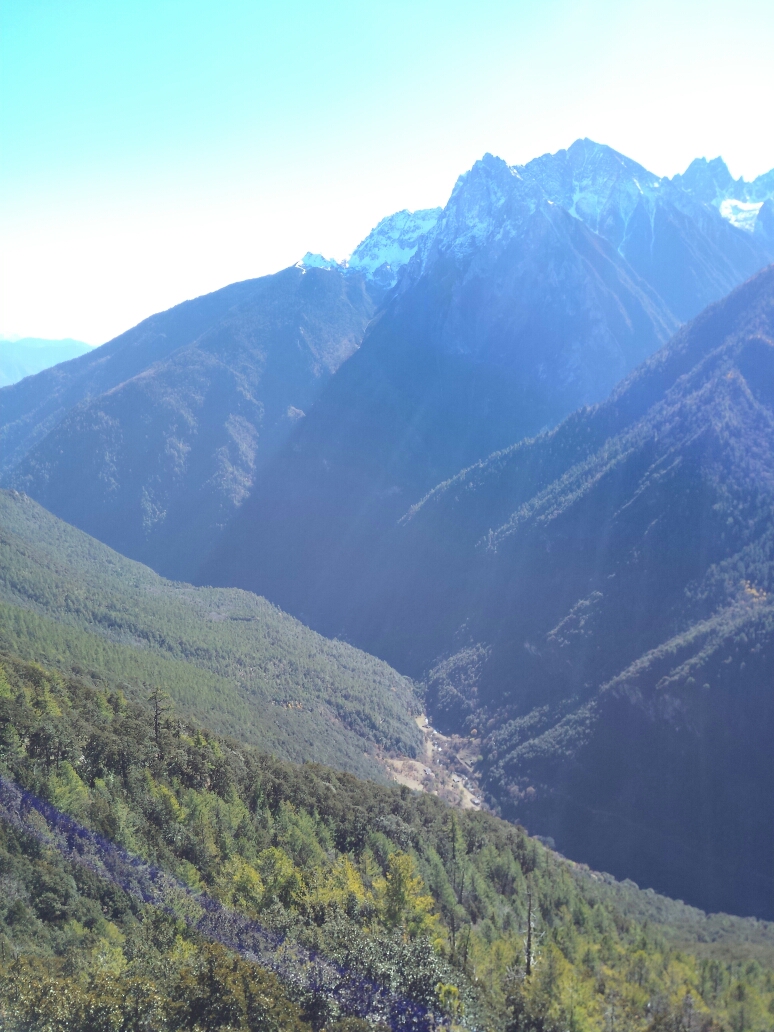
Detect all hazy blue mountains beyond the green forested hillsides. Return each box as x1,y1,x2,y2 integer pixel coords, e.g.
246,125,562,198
0,140,774,916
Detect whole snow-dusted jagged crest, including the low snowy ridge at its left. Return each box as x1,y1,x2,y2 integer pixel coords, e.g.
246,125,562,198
298,137,774,301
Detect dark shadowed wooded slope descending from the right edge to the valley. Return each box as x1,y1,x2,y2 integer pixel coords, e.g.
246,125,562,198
352,266,774,915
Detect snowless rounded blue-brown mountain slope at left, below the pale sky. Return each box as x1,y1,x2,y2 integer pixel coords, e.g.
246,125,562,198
0,268,374,576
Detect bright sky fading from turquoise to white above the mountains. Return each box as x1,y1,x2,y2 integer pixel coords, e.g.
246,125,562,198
0,0,774,344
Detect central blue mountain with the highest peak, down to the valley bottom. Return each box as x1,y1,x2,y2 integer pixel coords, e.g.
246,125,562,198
204,140,774,631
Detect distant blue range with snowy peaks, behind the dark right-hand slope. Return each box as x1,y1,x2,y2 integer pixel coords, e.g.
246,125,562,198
6,140,774,590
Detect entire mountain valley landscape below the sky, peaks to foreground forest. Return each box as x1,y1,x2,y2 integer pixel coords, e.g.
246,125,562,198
0,139,774,1032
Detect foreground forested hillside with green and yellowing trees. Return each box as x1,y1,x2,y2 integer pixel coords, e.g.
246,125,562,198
0,655,774,1032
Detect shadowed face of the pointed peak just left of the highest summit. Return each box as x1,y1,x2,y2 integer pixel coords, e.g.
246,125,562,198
200,149,677,634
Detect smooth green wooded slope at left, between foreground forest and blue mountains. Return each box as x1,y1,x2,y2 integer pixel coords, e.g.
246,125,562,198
0,491,420,779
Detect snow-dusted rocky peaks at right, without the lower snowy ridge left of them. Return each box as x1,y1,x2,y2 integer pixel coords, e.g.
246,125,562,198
400,138,774,321
